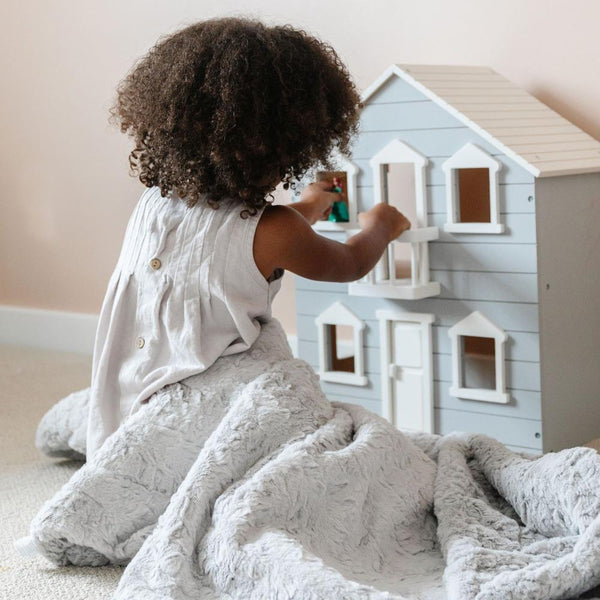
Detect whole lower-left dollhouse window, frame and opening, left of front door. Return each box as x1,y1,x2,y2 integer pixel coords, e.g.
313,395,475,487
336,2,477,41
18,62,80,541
315,302,367,386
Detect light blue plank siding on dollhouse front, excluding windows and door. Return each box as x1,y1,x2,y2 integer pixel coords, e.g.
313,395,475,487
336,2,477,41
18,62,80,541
295,78,542,450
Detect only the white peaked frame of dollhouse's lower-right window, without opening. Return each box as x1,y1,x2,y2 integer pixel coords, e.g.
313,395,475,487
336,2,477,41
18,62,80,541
448,311,510,404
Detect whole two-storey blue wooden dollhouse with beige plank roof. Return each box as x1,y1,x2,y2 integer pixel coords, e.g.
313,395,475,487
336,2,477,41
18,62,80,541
296,65,600,452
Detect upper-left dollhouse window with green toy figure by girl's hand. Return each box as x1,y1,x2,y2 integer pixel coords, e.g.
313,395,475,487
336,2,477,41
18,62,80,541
310,154,359,231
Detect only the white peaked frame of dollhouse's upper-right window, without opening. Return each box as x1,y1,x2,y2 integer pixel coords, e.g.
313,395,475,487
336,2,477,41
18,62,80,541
442,142,504,234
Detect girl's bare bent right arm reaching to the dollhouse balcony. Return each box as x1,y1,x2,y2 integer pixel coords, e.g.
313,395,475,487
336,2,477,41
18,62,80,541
254,203,410,282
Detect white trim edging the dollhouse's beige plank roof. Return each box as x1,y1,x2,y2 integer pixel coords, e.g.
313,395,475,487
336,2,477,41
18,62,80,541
361,64,600,177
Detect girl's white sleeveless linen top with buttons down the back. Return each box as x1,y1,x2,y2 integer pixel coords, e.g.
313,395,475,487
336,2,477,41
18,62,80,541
87,188,283,457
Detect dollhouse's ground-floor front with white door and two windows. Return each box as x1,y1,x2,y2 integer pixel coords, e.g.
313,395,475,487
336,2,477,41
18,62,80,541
296,278,544,453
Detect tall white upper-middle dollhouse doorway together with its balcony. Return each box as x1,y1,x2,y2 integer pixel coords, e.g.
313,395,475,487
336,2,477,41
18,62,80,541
348,139,440,300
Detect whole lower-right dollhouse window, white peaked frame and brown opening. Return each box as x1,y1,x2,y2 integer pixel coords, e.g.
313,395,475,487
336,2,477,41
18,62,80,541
448,311,510,404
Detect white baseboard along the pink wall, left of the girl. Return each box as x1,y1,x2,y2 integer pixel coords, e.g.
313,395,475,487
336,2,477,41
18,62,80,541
0,305,98,354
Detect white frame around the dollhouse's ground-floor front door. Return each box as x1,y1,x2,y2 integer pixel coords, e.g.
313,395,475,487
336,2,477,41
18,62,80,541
375,309,435,433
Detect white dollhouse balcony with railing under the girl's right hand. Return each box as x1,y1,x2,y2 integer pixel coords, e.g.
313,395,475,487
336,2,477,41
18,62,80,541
348,227,440,300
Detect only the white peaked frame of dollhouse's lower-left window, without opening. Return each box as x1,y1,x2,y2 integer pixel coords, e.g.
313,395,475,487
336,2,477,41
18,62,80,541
315,302,368,386
